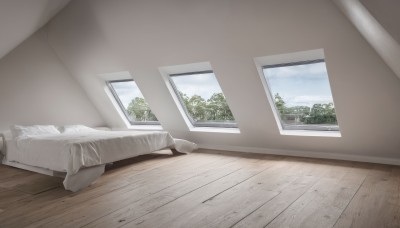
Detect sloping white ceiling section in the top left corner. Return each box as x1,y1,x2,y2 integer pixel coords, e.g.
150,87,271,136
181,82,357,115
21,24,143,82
0,0,70,58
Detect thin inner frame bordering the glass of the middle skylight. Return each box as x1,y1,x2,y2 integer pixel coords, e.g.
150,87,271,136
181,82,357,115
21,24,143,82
168,70,238,129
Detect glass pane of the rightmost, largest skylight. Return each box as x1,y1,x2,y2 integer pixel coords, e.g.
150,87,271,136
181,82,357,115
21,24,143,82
263,60,339,131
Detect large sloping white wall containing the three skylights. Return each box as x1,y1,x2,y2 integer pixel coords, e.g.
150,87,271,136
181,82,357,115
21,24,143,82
47,0,400,158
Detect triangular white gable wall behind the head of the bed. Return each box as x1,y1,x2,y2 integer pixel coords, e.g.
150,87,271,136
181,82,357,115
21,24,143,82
0,31,104,131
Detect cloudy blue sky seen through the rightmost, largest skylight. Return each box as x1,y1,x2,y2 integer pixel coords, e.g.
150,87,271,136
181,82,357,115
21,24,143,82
263,62,333,107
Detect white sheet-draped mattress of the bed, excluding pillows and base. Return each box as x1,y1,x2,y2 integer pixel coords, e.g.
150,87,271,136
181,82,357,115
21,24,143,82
6,131,174,175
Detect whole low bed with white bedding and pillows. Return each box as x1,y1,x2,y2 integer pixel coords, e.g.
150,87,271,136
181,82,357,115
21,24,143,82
0,125,197,192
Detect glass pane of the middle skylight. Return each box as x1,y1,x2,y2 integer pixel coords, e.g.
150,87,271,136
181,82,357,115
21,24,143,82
171,72,236,127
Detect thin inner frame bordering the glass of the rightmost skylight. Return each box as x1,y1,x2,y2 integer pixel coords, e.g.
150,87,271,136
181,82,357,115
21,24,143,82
261,58,340,134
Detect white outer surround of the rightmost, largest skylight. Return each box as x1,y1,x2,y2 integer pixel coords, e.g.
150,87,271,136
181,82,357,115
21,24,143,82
254,49,341,137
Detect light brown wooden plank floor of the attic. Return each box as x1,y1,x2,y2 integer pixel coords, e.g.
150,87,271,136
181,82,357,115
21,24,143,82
0,150,400,228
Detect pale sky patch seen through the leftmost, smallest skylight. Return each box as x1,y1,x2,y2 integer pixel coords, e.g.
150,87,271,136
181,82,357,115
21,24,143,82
111,81,143,109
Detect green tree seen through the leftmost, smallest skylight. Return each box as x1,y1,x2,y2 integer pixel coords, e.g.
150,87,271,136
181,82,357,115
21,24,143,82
127,97,157,121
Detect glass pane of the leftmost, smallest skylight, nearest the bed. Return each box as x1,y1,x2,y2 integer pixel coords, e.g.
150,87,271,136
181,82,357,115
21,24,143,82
109,80,158,124
